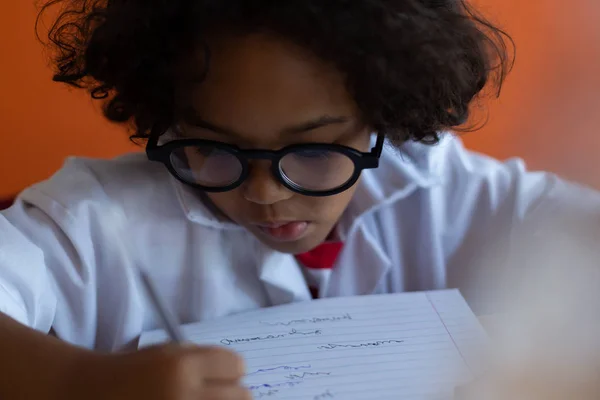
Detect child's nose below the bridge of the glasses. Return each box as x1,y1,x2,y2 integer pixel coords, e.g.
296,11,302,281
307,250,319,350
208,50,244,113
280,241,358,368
243,161,294,205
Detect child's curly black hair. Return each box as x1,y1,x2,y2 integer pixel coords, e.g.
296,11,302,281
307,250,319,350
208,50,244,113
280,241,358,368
38,0,513,144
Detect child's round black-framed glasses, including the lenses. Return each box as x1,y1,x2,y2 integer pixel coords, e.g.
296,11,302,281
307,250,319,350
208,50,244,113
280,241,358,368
146,134,385,196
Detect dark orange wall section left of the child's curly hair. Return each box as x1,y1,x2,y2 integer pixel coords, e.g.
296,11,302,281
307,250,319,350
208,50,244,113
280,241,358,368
0,0,134,196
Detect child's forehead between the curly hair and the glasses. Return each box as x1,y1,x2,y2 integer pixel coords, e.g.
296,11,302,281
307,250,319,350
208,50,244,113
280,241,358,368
177,34,357,138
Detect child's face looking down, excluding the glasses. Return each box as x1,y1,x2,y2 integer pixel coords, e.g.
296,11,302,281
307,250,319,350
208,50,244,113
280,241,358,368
179,34,370,254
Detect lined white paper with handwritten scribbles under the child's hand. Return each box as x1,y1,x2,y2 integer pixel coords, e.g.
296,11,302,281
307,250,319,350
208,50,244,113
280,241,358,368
140,290,486,400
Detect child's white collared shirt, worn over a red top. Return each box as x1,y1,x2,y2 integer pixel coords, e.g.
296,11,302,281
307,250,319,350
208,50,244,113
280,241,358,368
0,135,600,350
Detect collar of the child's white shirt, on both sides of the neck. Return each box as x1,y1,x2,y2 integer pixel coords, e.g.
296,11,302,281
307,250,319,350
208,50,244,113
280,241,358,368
172,134,451,232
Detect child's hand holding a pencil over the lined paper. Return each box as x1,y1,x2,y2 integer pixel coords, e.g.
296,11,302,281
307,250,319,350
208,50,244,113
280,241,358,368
73,345,252,400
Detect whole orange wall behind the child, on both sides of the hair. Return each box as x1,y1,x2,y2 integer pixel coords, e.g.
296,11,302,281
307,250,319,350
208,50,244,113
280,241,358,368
0,0,600,196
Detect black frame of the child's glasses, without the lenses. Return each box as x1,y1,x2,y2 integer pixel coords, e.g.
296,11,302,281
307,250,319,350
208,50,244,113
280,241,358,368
146,133,385,197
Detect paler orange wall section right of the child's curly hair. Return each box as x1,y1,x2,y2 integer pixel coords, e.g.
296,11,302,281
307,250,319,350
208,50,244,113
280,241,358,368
465,0,600,188
